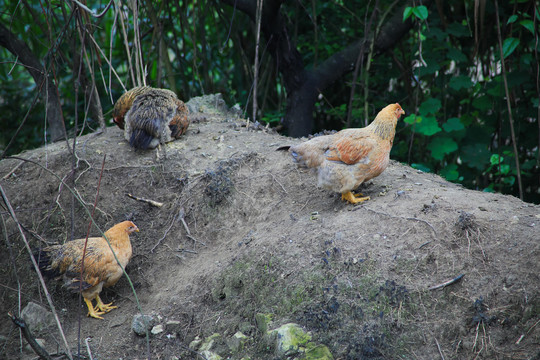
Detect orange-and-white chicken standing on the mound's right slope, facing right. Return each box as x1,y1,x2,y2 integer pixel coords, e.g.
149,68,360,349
279,103,405,204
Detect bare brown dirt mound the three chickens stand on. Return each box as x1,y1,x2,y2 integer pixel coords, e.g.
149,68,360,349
0,97,540,359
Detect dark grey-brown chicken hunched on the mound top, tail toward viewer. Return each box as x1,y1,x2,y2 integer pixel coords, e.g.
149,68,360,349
113,86,189,149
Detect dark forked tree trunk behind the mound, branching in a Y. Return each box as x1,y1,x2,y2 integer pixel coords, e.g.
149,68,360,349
222,0,422,137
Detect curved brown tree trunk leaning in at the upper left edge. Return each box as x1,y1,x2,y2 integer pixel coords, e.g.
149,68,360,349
0,24,66,141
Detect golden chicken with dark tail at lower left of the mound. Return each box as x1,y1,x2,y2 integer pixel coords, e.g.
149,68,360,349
36,221,139,319
